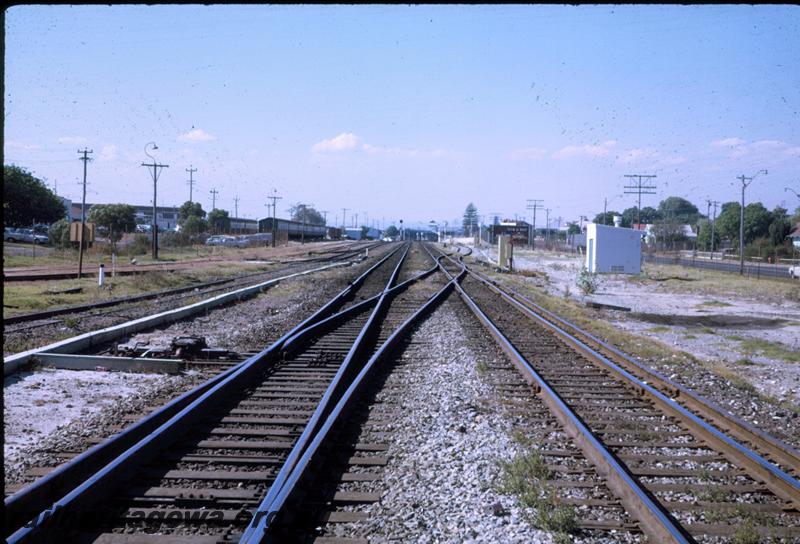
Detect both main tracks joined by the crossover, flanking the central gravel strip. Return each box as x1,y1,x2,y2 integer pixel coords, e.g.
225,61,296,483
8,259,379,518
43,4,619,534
6,244,800,543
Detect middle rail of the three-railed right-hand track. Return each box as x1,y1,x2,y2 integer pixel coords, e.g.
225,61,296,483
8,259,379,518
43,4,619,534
462,271,800,510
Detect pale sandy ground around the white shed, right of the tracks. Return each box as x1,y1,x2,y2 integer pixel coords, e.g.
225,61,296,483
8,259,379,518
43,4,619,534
474,243,800,404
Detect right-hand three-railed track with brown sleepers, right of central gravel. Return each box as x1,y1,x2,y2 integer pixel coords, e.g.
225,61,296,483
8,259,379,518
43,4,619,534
438,248,800,542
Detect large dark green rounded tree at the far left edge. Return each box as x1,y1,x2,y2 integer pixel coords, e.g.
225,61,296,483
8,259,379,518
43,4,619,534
3,164,67,227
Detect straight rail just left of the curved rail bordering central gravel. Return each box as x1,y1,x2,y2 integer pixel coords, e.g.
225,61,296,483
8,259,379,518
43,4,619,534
247,243,411,532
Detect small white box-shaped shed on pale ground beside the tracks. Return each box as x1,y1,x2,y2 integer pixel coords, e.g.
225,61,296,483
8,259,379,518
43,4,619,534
586,223,643,274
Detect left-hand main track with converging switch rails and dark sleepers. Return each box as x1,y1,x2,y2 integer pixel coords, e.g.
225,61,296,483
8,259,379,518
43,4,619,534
6,243,462,541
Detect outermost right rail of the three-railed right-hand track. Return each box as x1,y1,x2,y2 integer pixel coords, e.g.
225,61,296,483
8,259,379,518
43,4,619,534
470,270,800,471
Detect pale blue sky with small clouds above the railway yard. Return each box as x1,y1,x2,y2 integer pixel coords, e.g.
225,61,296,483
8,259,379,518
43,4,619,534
4,5,800,230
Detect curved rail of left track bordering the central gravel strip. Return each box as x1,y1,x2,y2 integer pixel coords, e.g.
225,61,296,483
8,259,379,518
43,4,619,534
244,249,456,544
